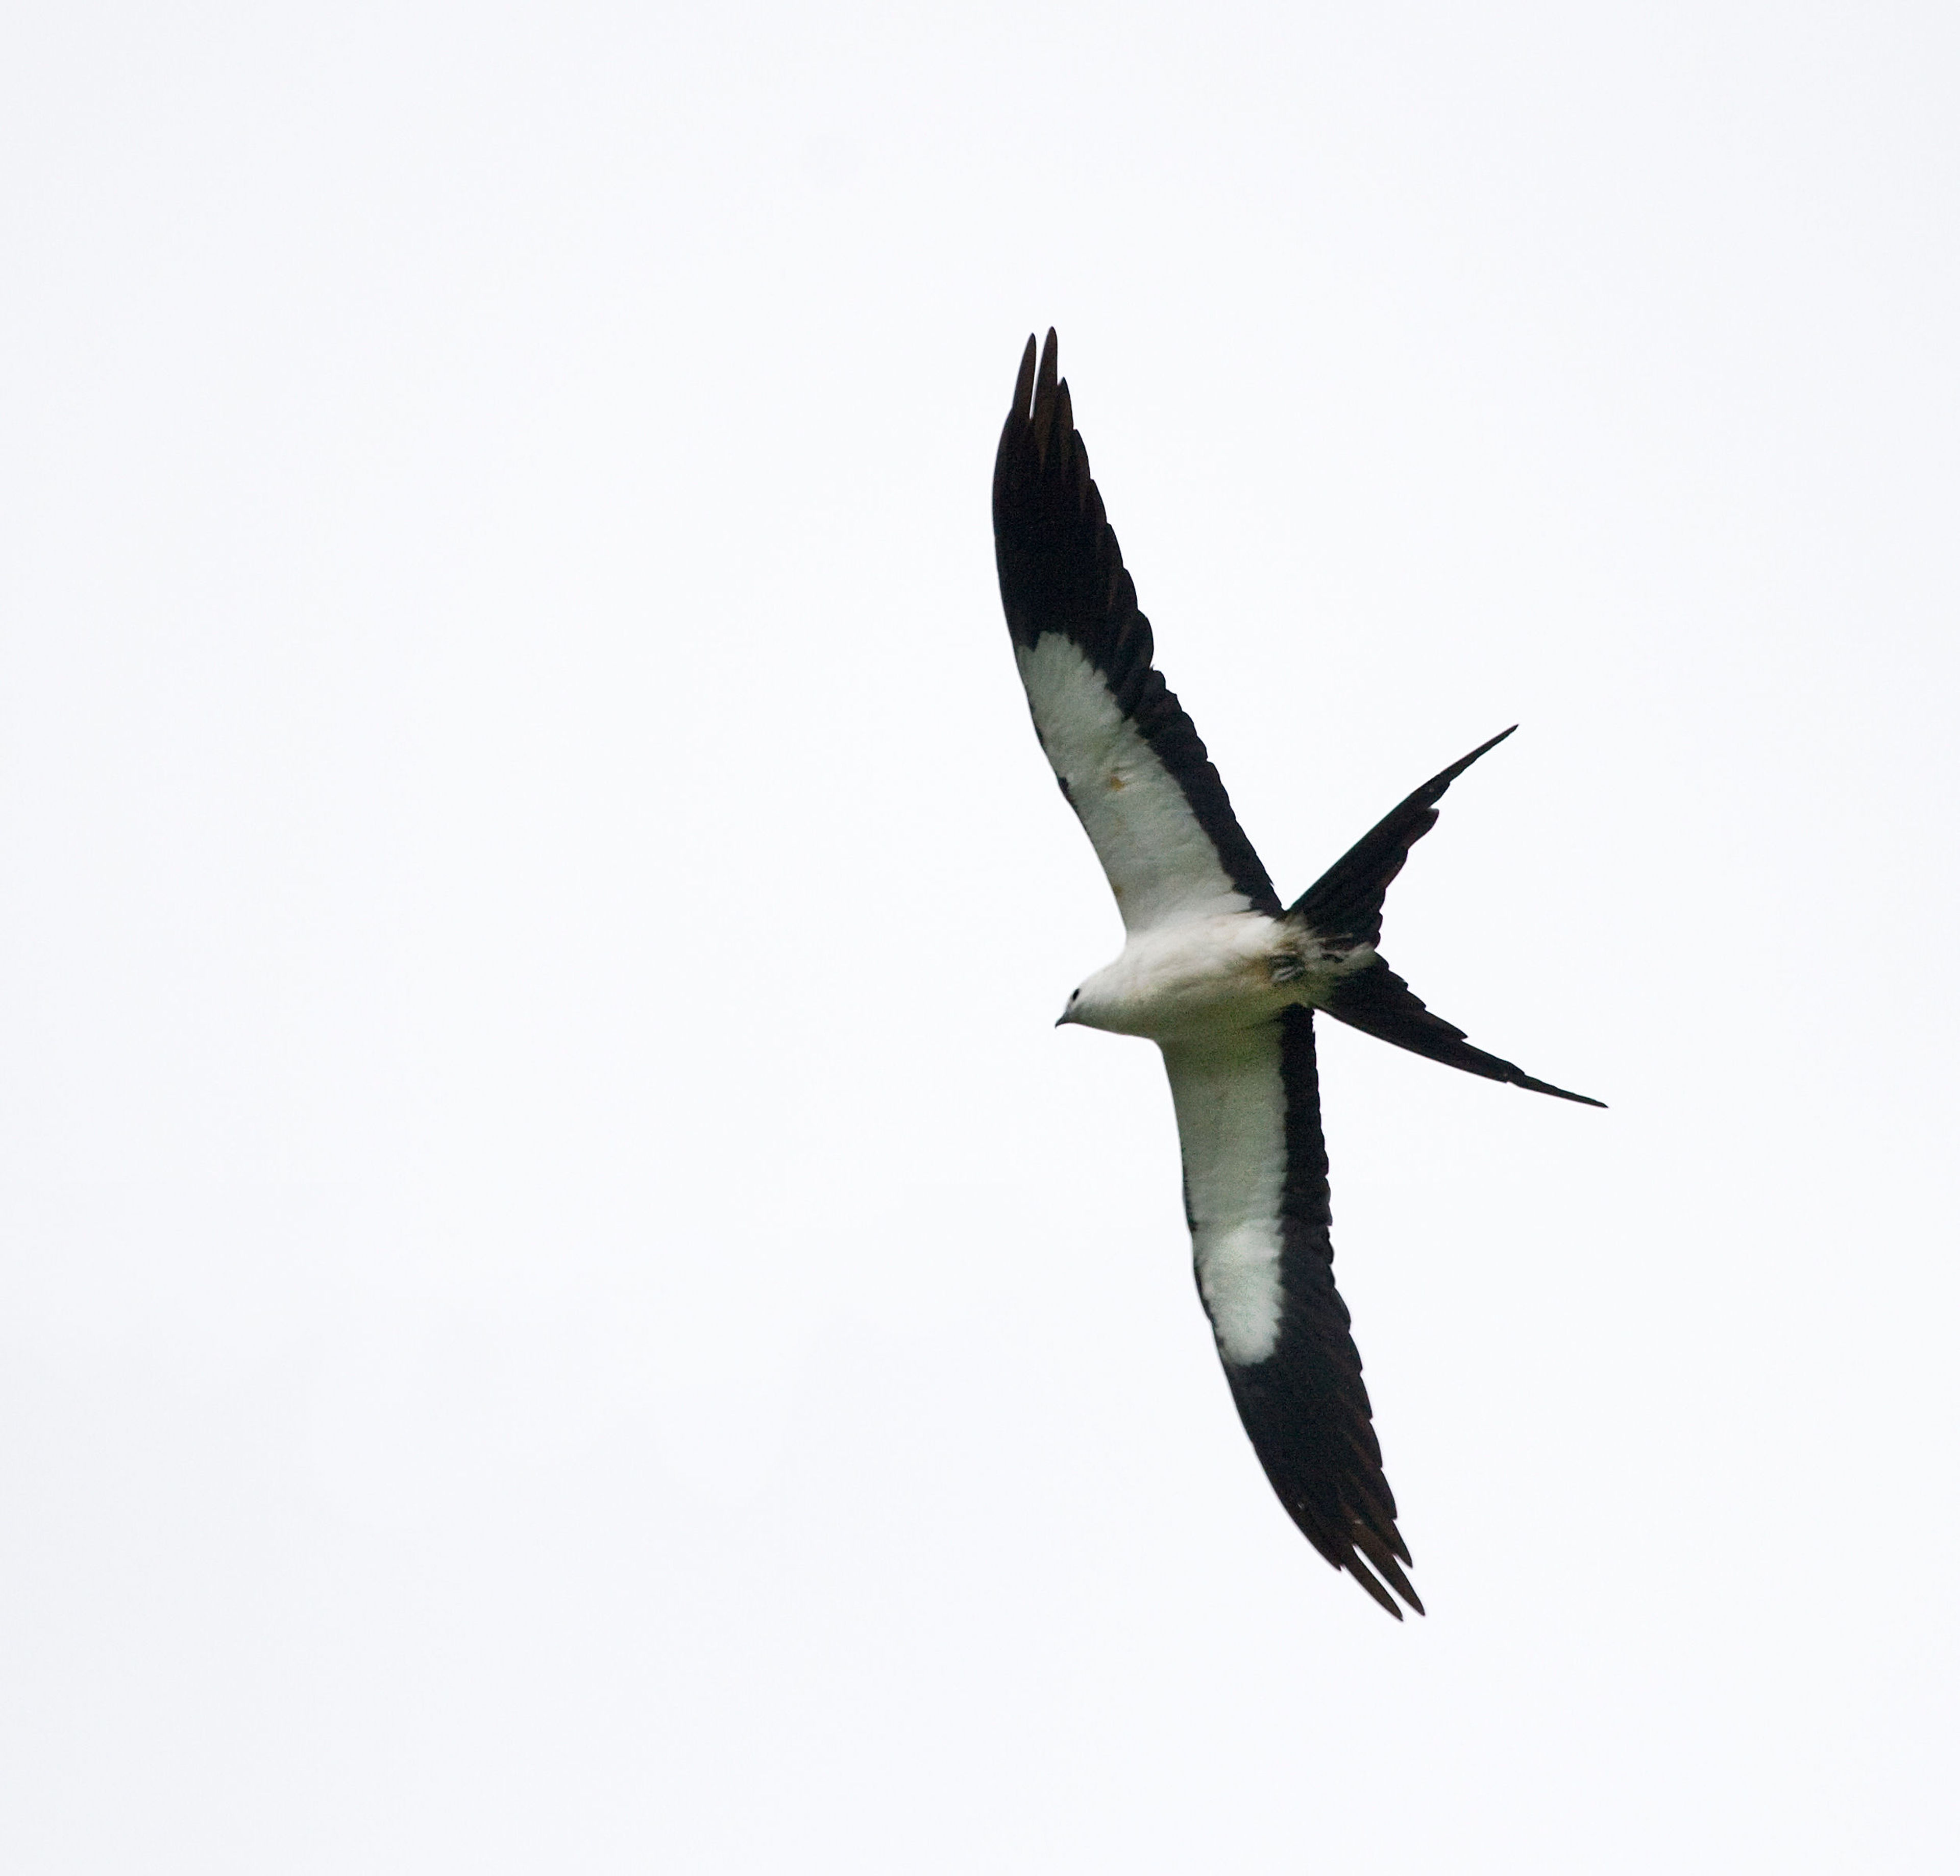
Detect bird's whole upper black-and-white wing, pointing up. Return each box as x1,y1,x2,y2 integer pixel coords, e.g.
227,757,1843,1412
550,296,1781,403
994,329,1280,931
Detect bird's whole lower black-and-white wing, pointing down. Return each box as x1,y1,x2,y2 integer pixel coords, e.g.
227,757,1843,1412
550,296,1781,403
1164,1006,1423,1621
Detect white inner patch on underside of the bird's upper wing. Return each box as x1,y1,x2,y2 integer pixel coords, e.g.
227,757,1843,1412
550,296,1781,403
1015,631,1251,931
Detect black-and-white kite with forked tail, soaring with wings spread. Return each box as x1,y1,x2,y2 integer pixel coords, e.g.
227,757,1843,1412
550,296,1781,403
994,329,1605,1621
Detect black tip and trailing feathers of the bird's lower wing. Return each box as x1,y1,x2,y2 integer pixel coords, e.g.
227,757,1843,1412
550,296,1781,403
1225,1004,1423,1621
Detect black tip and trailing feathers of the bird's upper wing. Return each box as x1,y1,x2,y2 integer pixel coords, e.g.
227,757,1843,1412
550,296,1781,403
994,341,1280,917
